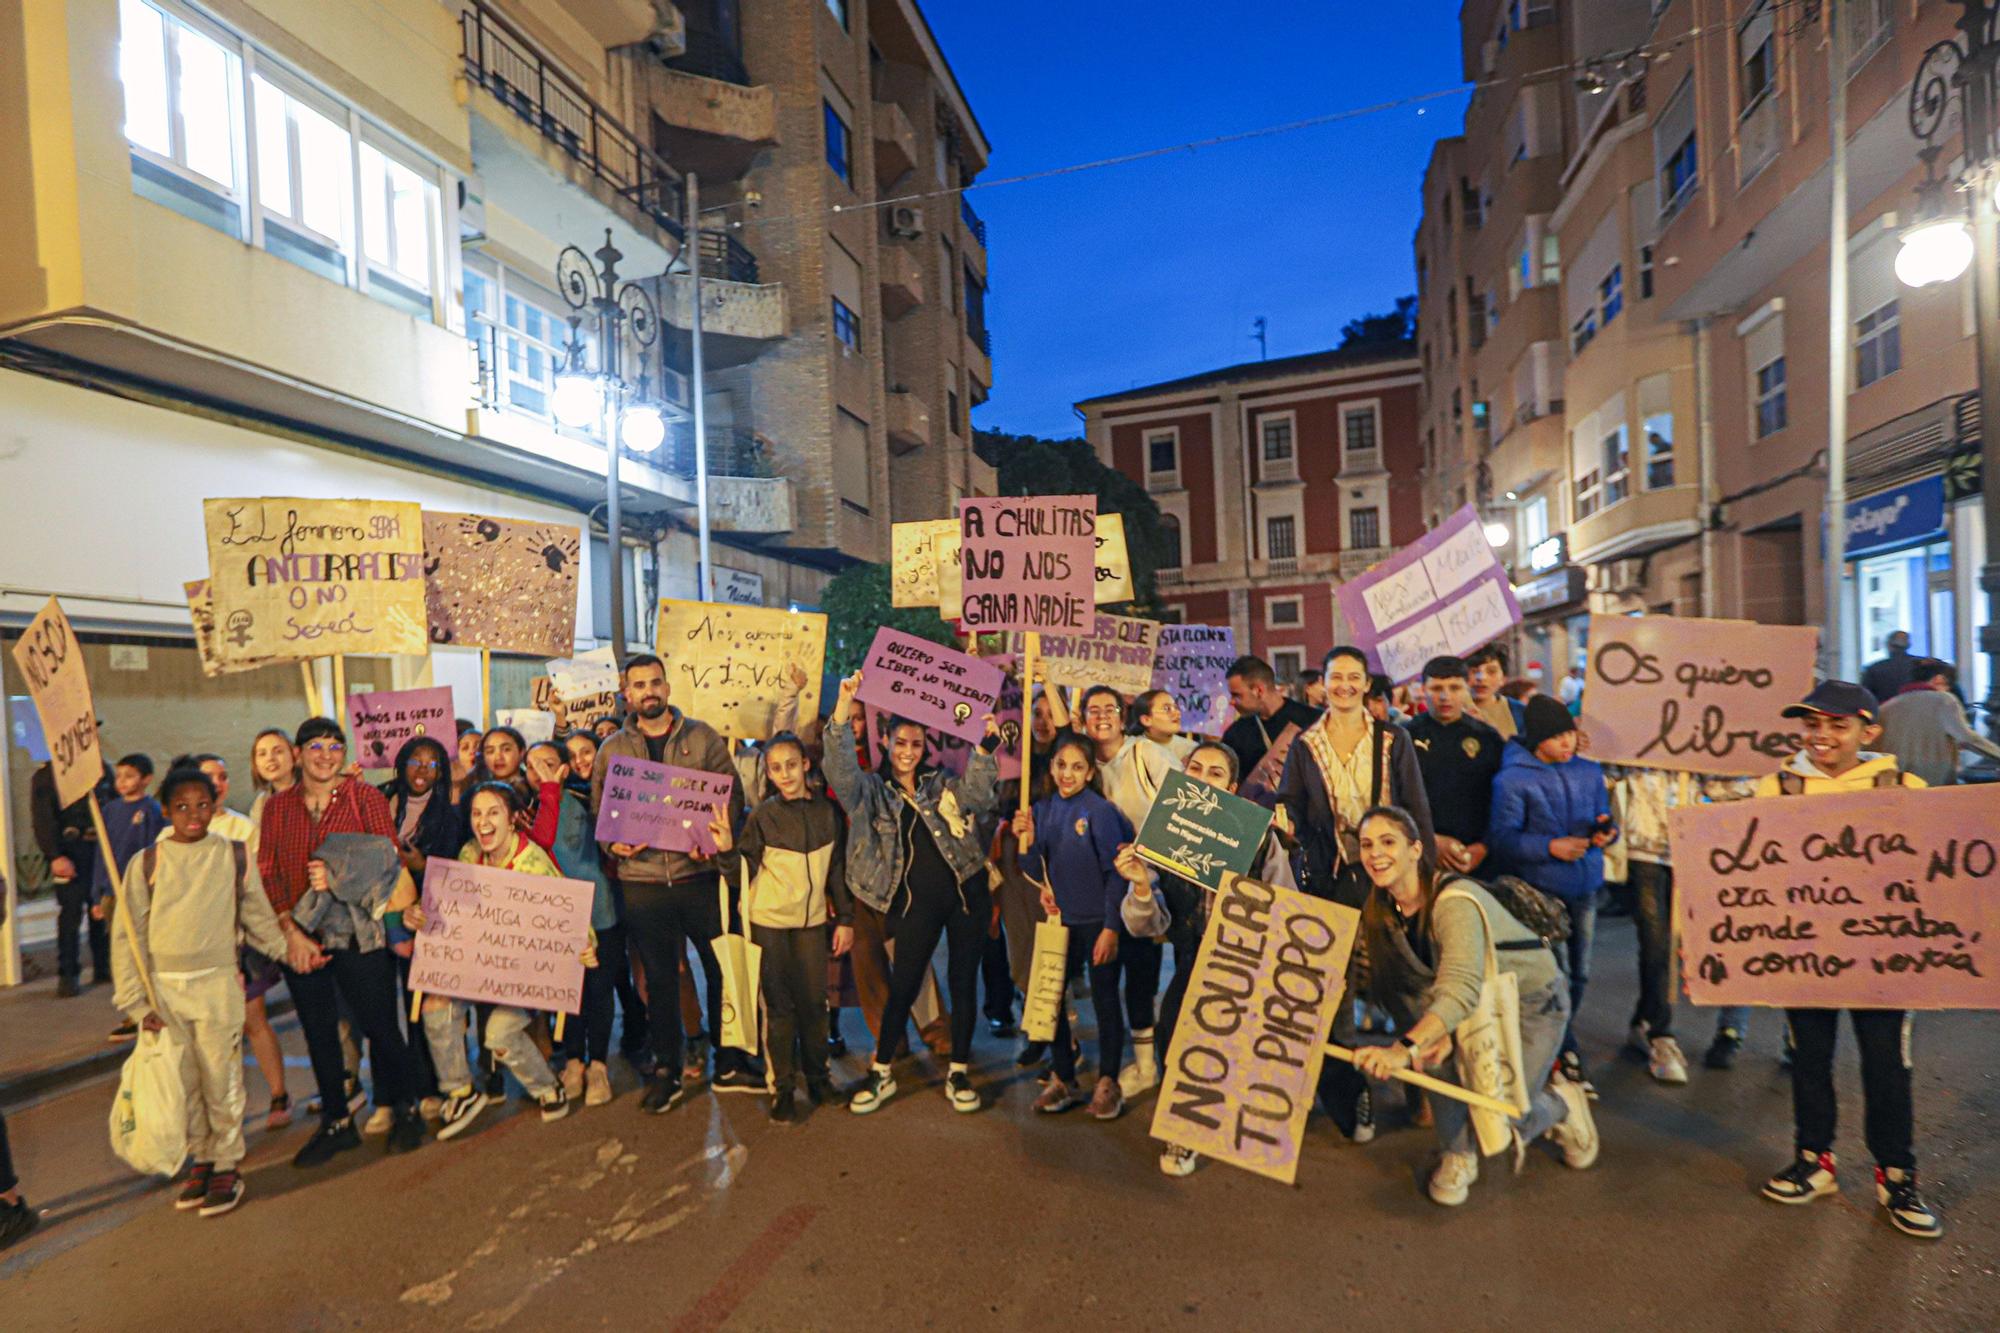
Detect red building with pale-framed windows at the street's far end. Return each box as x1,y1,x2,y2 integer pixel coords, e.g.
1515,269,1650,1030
1076,344,1424,681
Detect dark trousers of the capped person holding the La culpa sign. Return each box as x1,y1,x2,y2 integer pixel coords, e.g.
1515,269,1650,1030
1784,1009,1916,1171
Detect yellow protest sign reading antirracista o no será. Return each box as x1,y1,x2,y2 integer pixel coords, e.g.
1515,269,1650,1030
202,498,430,664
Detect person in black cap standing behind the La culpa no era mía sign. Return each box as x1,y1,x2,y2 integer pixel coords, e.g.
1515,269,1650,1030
1756,681,1944,1239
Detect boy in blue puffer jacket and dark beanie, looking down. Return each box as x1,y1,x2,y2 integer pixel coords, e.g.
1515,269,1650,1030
1486,695,1618,1097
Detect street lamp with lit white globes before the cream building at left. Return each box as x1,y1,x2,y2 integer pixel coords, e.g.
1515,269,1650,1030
548,228,666,656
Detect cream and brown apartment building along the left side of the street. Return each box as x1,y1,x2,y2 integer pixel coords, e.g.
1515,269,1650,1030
0,0,992,908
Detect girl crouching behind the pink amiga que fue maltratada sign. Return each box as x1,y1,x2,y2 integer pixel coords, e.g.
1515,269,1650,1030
402,783,580,1141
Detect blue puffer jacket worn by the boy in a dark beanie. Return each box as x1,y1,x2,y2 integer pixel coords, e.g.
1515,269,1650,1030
1482,739,1612,899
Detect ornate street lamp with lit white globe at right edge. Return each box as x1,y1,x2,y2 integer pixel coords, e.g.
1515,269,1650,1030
1896,0,2000,735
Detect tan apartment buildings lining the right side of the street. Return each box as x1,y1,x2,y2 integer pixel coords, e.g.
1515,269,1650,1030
1418,0,1986,695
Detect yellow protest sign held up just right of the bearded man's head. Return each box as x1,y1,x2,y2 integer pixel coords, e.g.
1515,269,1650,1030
654,598,826,741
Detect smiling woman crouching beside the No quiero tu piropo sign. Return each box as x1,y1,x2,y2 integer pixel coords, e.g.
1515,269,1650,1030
1348,805,1598,1207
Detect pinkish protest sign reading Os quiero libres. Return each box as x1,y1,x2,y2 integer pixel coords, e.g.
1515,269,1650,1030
1578,616,1820,777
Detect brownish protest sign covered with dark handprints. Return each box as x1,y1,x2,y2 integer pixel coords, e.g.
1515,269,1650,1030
424,508,584,656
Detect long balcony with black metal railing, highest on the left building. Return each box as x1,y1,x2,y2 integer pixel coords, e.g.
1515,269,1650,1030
458,0,686,236
